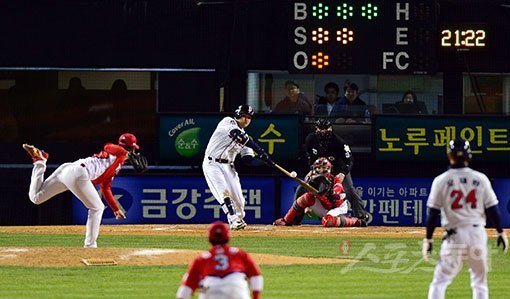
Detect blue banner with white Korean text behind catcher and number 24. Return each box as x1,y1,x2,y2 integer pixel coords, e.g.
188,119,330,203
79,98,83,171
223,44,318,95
280,178,510,227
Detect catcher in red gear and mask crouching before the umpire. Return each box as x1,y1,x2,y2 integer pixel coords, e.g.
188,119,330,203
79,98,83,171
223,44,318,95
273,157,367,227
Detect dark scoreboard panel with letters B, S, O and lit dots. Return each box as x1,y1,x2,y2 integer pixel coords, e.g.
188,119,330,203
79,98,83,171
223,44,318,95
289,0,438,74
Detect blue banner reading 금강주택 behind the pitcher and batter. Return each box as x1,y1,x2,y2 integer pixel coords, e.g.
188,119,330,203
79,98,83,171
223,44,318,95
73,176,275,224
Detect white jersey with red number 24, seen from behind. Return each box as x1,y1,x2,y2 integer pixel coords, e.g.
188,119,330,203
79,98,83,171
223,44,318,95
427,167,498,229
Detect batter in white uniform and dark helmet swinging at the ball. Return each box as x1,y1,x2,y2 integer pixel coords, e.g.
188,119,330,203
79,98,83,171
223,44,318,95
202,105,272,230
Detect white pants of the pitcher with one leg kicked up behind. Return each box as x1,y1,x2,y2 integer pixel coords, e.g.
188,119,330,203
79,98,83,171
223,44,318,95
28,161,105,248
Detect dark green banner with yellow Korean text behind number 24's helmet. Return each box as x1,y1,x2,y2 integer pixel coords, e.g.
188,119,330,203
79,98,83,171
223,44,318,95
373,115,510,162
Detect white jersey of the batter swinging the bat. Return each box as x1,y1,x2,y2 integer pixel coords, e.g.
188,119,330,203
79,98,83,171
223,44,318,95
201,117,255,162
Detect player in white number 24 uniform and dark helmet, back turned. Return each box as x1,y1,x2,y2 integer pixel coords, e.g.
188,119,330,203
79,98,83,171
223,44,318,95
422,139,508,299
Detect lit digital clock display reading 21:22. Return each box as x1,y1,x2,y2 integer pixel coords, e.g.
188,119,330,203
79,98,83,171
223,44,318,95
439,25,489,51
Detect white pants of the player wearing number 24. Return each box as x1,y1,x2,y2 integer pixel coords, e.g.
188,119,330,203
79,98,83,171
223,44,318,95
428,225,489,299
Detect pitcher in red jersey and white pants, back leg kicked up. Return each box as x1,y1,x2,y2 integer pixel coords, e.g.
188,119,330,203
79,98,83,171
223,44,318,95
23,133,139,248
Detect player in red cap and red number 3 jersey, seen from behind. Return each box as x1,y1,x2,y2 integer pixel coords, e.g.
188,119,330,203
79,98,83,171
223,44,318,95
177,221,264,299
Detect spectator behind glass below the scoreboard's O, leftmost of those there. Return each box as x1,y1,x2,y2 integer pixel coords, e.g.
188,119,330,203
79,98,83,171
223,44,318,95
273,80,312,115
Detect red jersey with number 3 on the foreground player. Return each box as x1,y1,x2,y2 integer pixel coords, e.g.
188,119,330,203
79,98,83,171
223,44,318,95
177,245,262,297
